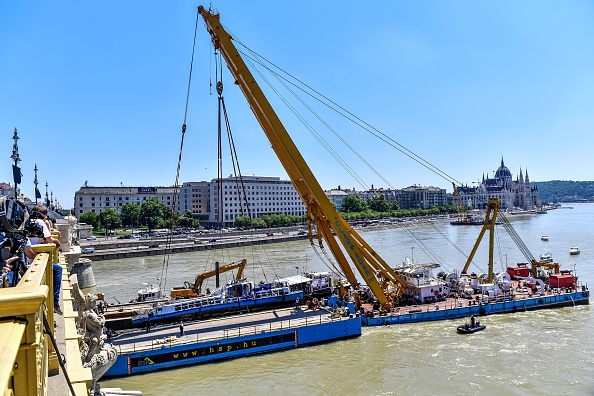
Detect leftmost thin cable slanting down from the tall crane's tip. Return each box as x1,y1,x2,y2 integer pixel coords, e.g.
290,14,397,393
159,6,200,290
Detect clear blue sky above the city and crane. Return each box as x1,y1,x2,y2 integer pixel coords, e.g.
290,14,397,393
0,0,594,208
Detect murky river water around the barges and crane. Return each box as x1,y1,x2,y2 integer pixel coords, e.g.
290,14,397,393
93,204,594,396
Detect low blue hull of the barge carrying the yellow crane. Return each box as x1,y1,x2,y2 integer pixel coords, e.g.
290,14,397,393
361,286,590,326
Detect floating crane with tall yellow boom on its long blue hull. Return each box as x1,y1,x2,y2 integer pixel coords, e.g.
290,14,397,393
198,6,590,325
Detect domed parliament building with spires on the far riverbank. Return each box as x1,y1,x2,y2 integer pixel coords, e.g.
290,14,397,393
458,157,542,212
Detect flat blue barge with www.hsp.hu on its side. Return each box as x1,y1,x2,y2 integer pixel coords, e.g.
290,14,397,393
104,309,361,377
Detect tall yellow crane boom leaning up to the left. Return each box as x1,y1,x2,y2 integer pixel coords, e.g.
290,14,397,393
198,6,406,308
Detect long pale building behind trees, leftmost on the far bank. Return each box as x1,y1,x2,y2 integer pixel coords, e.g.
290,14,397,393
74,186,179,218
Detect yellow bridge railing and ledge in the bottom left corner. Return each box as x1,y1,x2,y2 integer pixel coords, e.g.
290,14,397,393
0,244,92,396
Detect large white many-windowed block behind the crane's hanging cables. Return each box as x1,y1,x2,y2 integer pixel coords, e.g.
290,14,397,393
209,176,307,225
